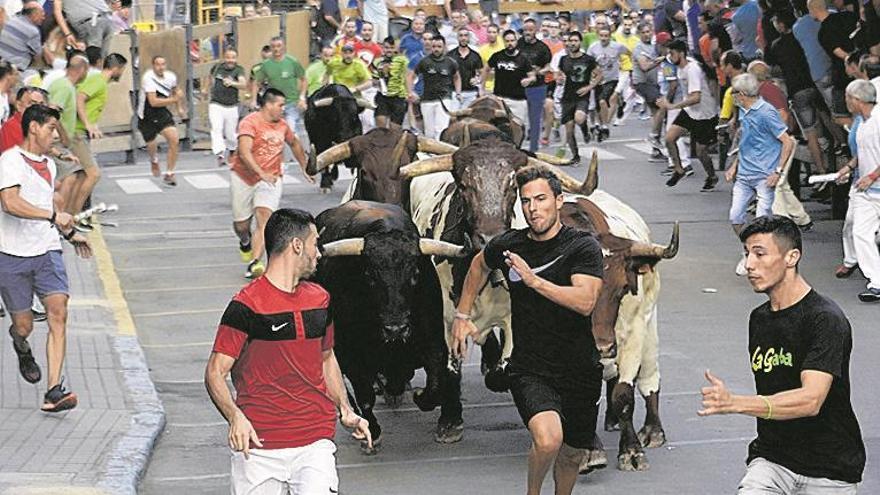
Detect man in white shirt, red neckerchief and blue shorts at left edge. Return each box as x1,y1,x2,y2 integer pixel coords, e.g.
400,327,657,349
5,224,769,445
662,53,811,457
0,105,91,412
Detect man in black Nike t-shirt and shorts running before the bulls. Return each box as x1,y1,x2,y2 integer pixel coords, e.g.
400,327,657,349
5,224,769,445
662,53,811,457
452,167,603,495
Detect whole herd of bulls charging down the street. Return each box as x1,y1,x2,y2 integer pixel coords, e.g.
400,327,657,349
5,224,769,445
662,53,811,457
305,85,679,470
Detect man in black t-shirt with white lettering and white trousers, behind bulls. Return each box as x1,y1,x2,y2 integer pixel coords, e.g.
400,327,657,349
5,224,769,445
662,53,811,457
481,29,537,136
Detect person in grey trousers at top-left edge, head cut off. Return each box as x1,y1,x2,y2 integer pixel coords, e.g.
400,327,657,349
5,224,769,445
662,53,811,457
53,0,115,56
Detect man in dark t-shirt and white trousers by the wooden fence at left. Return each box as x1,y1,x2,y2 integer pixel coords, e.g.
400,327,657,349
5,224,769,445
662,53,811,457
208,47,247,166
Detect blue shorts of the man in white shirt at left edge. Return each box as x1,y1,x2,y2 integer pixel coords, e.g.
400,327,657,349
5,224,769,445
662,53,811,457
0,251,70,313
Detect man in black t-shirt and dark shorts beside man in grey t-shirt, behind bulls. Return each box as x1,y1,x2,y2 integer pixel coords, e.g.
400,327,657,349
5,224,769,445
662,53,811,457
556,31,602,165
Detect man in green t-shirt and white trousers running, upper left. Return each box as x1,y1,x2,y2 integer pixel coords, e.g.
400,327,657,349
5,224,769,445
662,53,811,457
251,36,309,149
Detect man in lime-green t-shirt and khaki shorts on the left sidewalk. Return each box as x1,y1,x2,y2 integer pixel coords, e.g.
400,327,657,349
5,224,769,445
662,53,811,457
67,51,128,231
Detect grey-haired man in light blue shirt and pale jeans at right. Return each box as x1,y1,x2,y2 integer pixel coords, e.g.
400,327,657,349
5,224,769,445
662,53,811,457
724,74,795,276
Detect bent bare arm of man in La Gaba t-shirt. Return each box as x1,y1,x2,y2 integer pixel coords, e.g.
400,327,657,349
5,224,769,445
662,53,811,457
697,370,834,421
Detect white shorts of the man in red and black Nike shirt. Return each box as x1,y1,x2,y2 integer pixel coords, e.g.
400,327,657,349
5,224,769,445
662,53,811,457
230,439,339,495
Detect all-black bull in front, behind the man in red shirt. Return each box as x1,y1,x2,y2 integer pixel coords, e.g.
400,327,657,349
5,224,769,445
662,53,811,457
316,201,463,453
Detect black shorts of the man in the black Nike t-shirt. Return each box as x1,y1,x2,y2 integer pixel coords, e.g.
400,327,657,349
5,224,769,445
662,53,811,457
508,367,602,449
